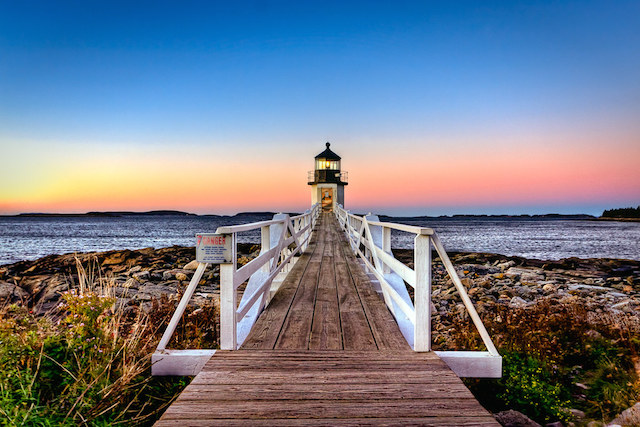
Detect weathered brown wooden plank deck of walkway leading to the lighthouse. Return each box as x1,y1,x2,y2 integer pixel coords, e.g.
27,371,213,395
156,214,499,426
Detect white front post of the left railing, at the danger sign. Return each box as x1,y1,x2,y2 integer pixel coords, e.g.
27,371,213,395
220,233,238,350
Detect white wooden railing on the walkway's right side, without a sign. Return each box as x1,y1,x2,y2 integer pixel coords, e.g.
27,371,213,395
335,206,502,378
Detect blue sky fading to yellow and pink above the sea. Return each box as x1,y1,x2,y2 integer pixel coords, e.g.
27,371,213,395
0,0,640,215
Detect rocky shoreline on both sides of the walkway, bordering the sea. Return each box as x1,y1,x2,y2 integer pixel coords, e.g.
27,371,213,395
0,244,640,328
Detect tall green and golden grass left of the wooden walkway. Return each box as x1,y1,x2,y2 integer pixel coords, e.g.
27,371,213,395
0,261,217,426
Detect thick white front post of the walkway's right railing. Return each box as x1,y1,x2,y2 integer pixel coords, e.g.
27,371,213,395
413,234,431,351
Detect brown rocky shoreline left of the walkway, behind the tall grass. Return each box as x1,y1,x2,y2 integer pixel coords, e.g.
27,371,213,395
0,244,259,314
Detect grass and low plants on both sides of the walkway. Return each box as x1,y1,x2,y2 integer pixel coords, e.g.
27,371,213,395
0,261,640,426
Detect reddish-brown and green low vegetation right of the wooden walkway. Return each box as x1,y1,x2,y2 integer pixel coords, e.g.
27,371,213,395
447,299,640,424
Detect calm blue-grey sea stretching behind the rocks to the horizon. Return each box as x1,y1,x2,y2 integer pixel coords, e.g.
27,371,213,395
0,215,640,264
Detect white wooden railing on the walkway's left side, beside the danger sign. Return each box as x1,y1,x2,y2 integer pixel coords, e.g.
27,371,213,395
152,204,320,375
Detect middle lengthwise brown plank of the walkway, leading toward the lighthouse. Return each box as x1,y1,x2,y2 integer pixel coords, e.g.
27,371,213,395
309,241,343,350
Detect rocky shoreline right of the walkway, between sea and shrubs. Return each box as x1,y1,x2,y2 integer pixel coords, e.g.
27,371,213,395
394,249,640,313
